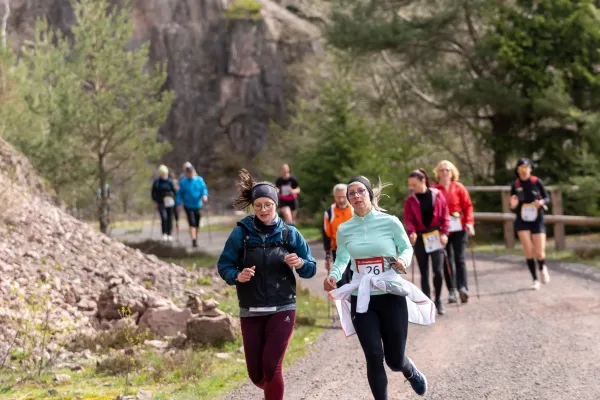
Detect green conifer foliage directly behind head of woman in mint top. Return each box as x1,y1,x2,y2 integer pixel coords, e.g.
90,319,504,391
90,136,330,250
291,79,419,216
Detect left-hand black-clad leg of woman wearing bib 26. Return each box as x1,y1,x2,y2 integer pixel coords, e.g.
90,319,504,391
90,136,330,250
351,296,387,400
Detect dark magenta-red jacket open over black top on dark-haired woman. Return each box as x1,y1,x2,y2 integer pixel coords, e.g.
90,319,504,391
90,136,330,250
404,188,450,235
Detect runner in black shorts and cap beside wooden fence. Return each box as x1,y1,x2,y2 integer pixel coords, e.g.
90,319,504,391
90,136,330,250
510,158,550,290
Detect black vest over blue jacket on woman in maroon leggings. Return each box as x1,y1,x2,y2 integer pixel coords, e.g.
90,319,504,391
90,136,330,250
236,223,296,308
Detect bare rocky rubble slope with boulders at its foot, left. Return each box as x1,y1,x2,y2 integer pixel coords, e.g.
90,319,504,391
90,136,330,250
0,140,235,365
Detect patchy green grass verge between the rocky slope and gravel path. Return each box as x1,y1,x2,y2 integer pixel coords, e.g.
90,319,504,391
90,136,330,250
0,256,329,400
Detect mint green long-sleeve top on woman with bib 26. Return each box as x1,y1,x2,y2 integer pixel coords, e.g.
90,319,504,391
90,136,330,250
329,209,413,295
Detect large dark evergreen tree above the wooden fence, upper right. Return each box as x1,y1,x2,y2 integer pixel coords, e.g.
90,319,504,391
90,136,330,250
328,0,600,182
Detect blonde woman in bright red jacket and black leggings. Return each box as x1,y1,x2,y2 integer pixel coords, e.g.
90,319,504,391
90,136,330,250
431,160,475,303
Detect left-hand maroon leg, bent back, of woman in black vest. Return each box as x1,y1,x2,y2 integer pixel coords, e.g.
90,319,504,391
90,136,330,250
240,316,267,389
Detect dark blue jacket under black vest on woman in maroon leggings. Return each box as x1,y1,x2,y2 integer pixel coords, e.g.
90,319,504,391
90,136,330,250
217,215,317,285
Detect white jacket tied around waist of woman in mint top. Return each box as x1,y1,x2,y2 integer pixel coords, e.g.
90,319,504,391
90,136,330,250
329,270,436,337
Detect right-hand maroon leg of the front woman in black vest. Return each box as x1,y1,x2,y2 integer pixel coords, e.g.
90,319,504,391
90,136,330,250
262,310,296,400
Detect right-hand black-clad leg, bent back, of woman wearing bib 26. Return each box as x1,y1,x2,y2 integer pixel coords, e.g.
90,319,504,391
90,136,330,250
380,294,413,378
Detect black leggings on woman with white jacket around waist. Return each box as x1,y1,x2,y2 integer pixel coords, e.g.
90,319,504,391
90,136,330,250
351,294,413,400
